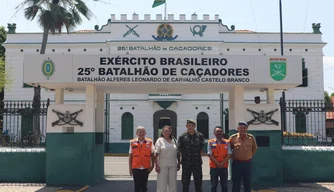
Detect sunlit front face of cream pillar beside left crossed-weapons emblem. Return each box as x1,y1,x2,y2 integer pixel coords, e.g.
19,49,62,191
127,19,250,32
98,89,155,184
85,85,96,132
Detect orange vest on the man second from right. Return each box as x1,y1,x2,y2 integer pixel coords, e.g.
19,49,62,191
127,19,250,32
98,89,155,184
208,139,229,168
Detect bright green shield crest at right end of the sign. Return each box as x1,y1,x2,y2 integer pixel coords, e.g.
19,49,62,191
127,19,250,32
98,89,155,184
270,58,286,81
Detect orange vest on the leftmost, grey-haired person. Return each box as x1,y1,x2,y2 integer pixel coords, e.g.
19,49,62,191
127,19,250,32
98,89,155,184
130,138,153,169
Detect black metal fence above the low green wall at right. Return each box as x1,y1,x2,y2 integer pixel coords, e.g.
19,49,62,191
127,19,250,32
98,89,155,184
280,92,334,145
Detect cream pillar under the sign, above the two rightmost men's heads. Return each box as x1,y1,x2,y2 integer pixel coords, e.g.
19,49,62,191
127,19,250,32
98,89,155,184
228,86,245,130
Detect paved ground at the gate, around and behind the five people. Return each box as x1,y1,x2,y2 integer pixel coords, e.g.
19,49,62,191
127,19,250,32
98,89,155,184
0,157,334,192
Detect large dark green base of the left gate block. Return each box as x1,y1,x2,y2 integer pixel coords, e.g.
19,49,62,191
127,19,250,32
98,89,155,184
46,133,104,185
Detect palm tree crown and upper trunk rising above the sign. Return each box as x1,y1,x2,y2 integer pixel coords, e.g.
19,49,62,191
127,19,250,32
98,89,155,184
18,0,99,54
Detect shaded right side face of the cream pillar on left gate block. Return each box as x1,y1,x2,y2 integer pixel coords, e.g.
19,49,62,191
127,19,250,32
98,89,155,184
95,91,105,133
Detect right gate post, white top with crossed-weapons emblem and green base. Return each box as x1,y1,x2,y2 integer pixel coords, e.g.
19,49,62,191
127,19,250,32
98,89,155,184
244,88,283,187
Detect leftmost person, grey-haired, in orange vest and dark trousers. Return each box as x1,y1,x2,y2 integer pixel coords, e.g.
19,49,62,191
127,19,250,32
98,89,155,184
129,126,154,192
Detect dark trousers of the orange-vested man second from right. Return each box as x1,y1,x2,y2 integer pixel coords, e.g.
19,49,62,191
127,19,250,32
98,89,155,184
210,168,228,192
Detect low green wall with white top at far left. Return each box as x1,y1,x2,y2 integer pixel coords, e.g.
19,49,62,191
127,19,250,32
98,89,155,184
0,148,46,183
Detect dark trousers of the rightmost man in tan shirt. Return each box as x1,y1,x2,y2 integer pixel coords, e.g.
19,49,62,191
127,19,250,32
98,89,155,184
232,161,252,192
